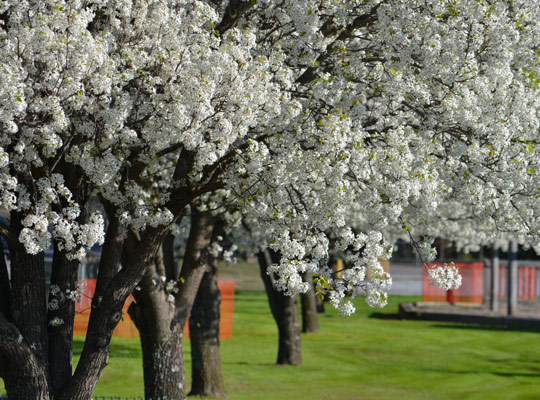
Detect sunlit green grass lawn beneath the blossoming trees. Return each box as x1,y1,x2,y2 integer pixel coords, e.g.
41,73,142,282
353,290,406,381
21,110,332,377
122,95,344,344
1,292,540,400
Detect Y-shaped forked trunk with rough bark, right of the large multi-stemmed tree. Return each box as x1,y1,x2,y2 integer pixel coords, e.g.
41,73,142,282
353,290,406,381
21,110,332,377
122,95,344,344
128,214,213,400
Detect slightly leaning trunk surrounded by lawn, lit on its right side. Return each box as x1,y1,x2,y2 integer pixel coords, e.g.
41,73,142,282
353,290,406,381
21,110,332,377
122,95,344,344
257,252,302,365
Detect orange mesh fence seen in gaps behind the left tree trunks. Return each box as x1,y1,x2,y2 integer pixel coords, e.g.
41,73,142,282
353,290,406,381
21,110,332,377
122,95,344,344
73,279,234,339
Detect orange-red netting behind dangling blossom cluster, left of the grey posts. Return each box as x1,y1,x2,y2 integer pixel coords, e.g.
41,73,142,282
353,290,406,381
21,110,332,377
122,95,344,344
422,262,484,303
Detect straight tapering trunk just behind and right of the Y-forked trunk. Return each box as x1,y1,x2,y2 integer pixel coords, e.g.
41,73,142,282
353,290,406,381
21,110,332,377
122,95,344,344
189,253,227,397
